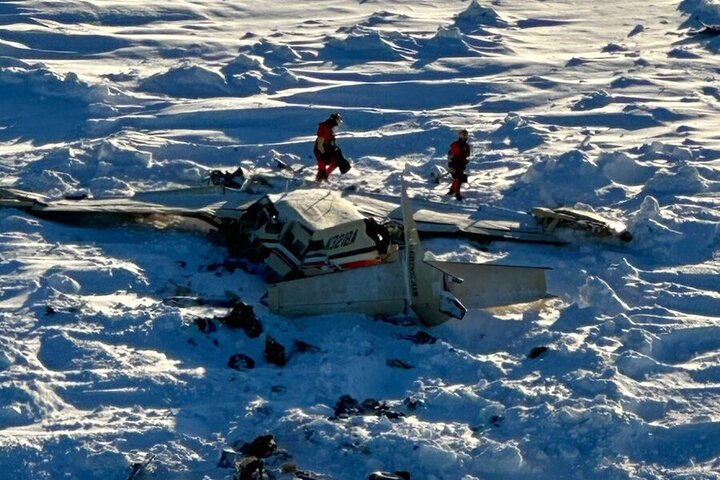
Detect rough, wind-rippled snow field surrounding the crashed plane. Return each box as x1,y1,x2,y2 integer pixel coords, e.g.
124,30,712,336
0,0,720,480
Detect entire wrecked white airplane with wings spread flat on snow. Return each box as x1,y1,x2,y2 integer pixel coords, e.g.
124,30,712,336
0,177,616,325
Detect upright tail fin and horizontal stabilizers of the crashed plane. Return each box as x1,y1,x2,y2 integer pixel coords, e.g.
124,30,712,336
268,185,549,326
